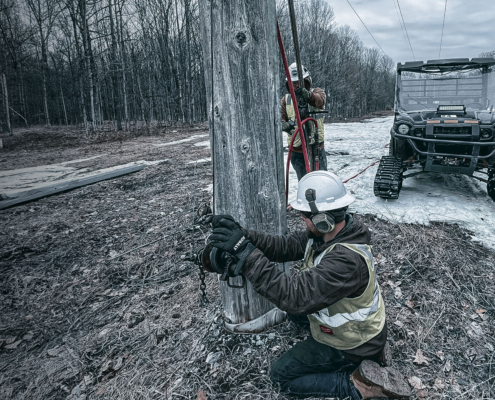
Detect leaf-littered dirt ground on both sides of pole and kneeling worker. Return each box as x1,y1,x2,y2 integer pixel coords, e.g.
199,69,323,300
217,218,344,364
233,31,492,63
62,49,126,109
0,125,495,400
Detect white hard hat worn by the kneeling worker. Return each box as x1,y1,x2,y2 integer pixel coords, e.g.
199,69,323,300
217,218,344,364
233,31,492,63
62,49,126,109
291,171,356,212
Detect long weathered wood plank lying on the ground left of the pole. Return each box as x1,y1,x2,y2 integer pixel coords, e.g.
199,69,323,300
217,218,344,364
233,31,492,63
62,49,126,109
0,165,146,210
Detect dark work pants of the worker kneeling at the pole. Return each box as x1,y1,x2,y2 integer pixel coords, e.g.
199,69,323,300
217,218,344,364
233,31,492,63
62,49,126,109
270,316,361,400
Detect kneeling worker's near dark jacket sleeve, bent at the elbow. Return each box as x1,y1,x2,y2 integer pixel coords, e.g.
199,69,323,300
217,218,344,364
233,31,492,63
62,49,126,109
243,246,369,315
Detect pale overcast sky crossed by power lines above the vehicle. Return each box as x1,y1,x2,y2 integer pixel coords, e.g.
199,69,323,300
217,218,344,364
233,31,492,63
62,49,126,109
327,0,495,62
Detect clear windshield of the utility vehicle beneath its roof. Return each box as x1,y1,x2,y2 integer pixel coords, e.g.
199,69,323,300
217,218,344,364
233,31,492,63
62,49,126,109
396,67,495,111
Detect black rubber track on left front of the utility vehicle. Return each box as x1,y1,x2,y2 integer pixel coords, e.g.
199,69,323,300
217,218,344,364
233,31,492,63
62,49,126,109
373,156,403,199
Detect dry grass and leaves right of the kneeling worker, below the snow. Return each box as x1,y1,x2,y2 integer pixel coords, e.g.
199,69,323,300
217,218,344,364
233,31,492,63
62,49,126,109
366,216,495,399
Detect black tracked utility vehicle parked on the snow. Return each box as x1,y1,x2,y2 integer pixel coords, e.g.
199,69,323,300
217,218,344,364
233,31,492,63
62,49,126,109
374,58,495,200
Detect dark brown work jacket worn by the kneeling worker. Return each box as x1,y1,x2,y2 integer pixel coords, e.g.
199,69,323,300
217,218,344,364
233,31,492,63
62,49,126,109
243,215,387,361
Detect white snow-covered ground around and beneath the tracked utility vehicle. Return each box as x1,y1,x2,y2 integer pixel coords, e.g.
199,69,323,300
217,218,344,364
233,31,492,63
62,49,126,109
284,117,495,248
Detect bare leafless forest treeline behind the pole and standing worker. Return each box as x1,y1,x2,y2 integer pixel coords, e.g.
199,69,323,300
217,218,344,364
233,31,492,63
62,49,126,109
0,0,395,131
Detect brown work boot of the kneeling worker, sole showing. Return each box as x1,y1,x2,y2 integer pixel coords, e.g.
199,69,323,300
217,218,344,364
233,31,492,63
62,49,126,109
351,360,411,399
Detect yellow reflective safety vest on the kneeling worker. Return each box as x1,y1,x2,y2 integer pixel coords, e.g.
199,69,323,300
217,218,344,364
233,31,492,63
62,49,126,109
302,239,385,350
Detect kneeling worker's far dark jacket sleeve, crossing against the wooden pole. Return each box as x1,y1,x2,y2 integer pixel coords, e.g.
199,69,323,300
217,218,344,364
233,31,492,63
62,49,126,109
246,231,308,263
